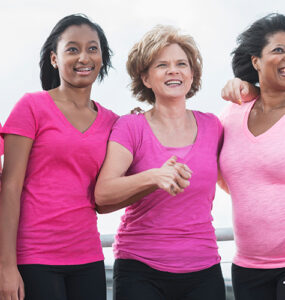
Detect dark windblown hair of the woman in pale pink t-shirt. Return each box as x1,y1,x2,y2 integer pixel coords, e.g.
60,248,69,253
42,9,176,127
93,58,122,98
232,13,285,84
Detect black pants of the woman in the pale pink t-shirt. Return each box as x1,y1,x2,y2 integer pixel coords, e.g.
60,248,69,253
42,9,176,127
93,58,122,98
232,264,285,300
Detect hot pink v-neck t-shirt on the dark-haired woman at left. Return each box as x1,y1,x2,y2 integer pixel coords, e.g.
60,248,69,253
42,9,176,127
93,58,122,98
2,91,117,265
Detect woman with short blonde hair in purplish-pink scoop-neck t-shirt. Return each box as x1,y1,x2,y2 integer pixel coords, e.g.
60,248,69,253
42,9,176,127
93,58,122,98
95,26,225,300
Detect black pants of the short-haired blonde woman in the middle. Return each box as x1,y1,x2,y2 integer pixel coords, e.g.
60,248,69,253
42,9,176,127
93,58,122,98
113,259,225,300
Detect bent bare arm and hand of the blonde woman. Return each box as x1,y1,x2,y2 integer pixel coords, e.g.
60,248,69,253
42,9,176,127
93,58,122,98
95,141,191,212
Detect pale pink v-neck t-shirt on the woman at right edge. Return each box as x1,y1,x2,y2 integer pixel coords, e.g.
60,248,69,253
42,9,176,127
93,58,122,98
220,101,285,269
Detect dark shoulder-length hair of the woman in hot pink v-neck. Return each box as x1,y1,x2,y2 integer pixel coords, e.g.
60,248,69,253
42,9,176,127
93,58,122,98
40,14,112,90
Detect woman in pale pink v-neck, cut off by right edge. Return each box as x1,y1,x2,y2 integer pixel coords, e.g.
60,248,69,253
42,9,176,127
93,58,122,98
220,14,285,300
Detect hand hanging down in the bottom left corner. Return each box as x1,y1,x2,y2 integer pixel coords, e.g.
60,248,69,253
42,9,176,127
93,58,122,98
0,266,25,300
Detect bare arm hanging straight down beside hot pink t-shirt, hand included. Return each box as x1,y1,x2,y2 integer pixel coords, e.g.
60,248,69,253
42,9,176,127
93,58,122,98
0,135,33,300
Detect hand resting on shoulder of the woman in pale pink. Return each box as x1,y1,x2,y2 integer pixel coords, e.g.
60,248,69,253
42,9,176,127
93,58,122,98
221,78,260,105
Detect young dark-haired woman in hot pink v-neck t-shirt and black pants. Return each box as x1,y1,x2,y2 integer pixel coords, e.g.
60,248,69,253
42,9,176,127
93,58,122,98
0,15,117,300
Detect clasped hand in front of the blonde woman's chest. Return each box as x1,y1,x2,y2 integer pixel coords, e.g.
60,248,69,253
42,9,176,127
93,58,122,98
154,156,192,196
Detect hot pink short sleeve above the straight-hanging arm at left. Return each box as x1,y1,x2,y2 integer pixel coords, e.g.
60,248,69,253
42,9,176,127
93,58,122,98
1,94,37,139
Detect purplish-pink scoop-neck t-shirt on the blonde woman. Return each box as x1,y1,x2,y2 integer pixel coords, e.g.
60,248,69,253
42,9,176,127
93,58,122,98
110,111,222,273
